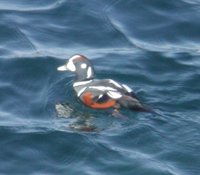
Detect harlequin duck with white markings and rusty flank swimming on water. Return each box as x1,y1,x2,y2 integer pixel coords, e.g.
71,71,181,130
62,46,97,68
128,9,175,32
57,55,151,112
